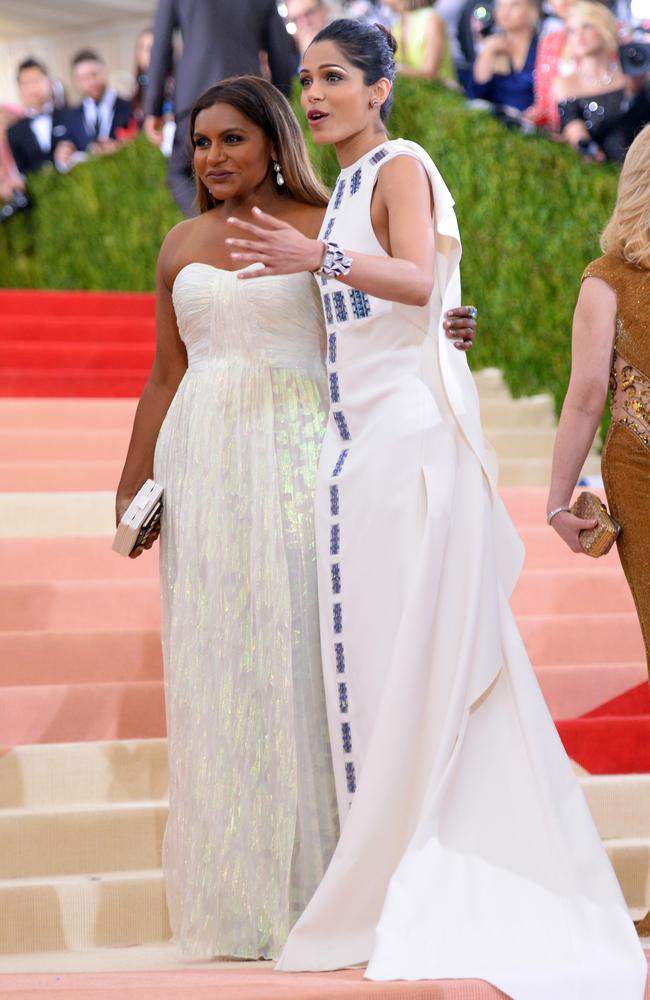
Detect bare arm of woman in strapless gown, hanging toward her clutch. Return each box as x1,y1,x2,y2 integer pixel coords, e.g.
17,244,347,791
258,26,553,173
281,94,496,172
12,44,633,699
116,241,187,522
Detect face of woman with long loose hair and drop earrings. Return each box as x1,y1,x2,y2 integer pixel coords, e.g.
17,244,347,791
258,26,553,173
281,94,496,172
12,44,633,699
192,103,274,201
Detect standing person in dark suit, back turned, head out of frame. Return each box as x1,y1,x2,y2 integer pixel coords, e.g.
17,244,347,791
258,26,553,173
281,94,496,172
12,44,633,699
144,0,297,215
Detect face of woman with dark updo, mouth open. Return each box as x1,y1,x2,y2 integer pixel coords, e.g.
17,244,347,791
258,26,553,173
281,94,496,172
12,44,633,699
300,41,390,145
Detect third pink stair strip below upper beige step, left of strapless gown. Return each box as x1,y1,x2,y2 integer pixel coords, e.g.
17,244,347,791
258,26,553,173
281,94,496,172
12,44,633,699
0,626,162,692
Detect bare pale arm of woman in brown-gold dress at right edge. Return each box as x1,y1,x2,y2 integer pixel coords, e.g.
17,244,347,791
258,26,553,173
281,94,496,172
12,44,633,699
547,278,616,552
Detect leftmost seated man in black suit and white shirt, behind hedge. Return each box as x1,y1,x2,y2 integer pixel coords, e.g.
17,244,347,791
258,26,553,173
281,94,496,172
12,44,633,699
7,59,67,174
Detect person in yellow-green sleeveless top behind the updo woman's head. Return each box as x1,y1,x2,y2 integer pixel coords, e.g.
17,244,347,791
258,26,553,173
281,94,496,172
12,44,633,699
385,0,456,81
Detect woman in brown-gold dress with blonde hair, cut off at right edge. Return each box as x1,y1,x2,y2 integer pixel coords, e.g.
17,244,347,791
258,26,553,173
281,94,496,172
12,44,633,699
548,125,650,934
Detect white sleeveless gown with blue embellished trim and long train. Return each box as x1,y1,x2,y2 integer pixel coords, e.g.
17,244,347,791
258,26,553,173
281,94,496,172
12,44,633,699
278,140,647,1000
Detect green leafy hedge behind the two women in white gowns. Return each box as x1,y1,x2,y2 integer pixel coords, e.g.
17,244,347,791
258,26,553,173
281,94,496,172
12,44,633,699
0,79,617,416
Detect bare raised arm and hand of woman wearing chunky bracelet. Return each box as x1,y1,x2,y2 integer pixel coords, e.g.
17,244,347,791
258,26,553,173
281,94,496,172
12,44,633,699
226,156,435,306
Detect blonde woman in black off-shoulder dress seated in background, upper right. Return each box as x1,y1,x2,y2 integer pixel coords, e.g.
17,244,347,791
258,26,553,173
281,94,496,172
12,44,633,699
553,0,625,160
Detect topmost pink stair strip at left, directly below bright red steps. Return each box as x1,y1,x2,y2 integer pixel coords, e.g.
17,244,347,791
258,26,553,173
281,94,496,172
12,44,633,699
0,398,137,430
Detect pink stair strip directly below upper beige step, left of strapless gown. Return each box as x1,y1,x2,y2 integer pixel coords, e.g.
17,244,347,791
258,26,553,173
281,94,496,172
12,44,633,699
0,536,158,583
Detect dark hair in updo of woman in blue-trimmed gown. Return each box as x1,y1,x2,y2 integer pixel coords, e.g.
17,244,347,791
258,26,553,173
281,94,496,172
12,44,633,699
311,18,397,121
